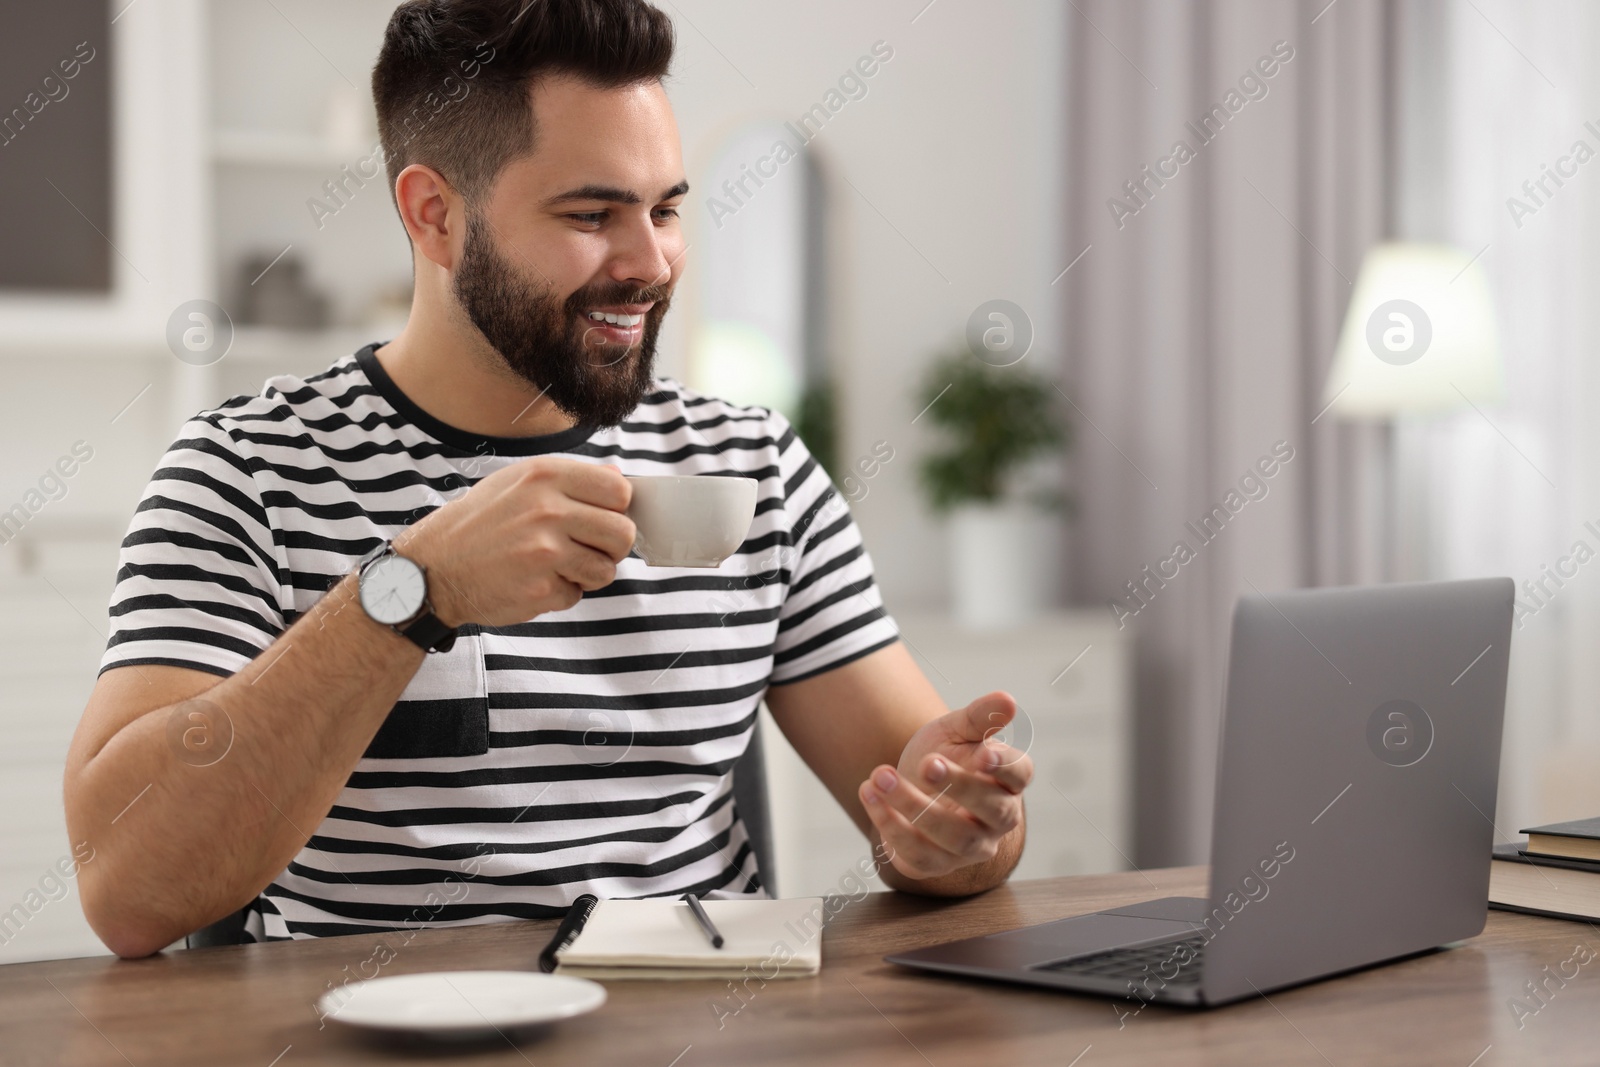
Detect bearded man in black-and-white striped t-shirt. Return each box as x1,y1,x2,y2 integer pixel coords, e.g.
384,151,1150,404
66,0,1032,957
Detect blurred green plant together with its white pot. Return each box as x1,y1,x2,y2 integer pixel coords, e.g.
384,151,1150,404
918,349,1069,629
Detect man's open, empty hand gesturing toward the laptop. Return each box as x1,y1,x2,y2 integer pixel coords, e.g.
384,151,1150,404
858,693,1034,880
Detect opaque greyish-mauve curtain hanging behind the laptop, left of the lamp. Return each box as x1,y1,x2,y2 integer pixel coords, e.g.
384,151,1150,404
1056,0,1401,865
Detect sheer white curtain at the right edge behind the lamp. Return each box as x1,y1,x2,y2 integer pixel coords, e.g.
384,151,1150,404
1408,0,1600,840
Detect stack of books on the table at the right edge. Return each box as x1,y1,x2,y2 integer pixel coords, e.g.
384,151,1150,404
1490,817,1600,921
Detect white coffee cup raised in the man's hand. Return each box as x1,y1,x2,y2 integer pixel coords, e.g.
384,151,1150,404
627,475,755,566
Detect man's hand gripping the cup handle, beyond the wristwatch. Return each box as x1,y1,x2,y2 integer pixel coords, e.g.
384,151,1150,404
395,456,634,627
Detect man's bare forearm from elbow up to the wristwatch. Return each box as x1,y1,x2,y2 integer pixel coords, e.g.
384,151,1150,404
67,576,424,955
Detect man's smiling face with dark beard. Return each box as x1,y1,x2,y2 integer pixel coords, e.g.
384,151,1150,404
453,75,688,426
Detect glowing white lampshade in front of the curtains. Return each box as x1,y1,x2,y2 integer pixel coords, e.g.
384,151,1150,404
1323,243,1506,419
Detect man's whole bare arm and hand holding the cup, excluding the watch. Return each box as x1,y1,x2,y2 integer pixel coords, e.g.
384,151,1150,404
66,458,634,957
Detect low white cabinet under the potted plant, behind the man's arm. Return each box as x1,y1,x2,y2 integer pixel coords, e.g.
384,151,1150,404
766,609,1133,896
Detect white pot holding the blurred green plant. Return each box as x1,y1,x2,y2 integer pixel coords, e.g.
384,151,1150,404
950,504,1061,630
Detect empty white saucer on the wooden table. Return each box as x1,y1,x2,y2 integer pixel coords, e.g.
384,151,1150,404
317,971,605,1038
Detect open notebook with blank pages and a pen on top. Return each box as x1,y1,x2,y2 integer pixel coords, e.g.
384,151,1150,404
557,896,824,977
